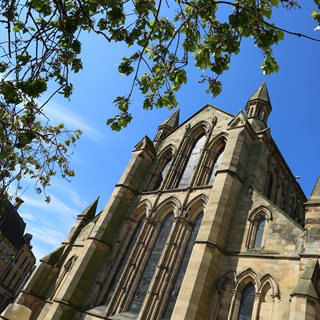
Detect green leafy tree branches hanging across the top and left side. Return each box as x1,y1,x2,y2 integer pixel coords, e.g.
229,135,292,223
0,0,320,200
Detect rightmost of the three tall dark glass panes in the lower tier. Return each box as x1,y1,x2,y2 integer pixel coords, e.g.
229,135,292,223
163,213,203,320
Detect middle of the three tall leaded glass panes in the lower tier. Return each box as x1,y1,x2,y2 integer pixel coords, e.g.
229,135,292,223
129,213,173,313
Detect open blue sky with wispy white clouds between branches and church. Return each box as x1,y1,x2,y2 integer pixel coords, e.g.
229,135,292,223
19,2,320,259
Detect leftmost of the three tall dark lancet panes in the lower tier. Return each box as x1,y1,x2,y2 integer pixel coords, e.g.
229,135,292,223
104,218,144,305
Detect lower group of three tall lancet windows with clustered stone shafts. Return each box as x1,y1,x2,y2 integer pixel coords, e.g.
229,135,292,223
101,198,209,320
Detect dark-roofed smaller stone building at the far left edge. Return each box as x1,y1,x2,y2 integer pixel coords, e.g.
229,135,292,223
0,203,36,312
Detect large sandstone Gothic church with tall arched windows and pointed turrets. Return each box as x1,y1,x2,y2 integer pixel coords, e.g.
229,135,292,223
16,84,320,320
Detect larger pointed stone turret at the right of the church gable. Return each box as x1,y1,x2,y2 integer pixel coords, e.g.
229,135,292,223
245,82,272,131
